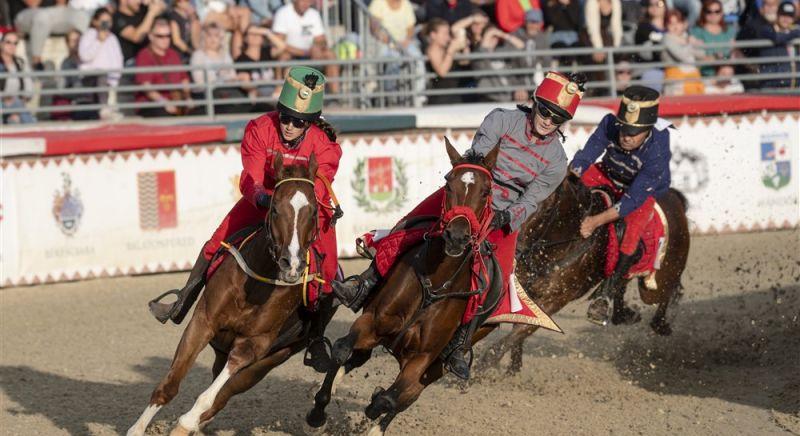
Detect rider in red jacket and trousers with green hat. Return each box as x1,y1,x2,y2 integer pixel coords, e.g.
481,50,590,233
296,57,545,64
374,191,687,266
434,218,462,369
150,67,342,324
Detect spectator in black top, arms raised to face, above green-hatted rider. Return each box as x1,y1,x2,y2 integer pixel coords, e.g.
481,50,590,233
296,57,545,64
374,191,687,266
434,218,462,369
236,26,286,112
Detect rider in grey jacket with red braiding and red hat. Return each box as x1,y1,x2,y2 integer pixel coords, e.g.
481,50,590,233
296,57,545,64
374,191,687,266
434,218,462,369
333,72,584,379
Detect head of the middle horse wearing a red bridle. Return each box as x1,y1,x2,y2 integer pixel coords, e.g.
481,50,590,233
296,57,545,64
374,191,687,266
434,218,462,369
442,137,499,257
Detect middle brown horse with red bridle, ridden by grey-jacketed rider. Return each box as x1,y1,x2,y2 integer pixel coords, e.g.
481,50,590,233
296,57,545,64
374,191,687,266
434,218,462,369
306,138,499,434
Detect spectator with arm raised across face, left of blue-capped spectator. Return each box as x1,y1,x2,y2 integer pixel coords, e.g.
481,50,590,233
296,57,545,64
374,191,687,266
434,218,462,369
471,19,528,102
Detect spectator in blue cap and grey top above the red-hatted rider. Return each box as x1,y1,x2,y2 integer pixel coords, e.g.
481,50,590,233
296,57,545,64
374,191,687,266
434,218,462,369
513,9,556,87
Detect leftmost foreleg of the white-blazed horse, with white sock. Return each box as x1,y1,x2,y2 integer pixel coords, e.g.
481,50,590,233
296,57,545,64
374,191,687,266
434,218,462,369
128,308,214,436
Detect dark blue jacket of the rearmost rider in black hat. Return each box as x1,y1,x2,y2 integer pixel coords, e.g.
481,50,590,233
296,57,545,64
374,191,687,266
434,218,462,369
570,114,672,217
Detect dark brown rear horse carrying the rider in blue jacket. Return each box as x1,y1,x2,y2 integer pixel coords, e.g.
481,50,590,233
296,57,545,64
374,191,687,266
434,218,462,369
476,176,689,373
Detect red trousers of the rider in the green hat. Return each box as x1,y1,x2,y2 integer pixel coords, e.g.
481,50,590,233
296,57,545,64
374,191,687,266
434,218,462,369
203,198,338,293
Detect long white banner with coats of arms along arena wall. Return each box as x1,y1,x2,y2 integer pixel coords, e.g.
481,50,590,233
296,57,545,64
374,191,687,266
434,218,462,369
0,115,800,286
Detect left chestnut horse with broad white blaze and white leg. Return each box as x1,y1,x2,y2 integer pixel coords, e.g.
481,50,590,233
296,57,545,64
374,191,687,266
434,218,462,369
128,154,335,435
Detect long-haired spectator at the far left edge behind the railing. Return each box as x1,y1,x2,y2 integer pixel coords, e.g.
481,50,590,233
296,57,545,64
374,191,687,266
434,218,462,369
0,32,36,124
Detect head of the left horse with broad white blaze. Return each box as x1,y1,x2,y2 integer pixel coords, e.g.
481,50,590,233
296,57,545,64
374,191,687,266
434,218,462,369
266,153,317,282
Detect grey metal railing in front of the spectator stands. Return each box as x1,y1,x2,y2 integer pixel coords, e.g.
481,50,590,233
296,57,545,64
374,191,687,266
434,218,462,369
0,38,800,121
